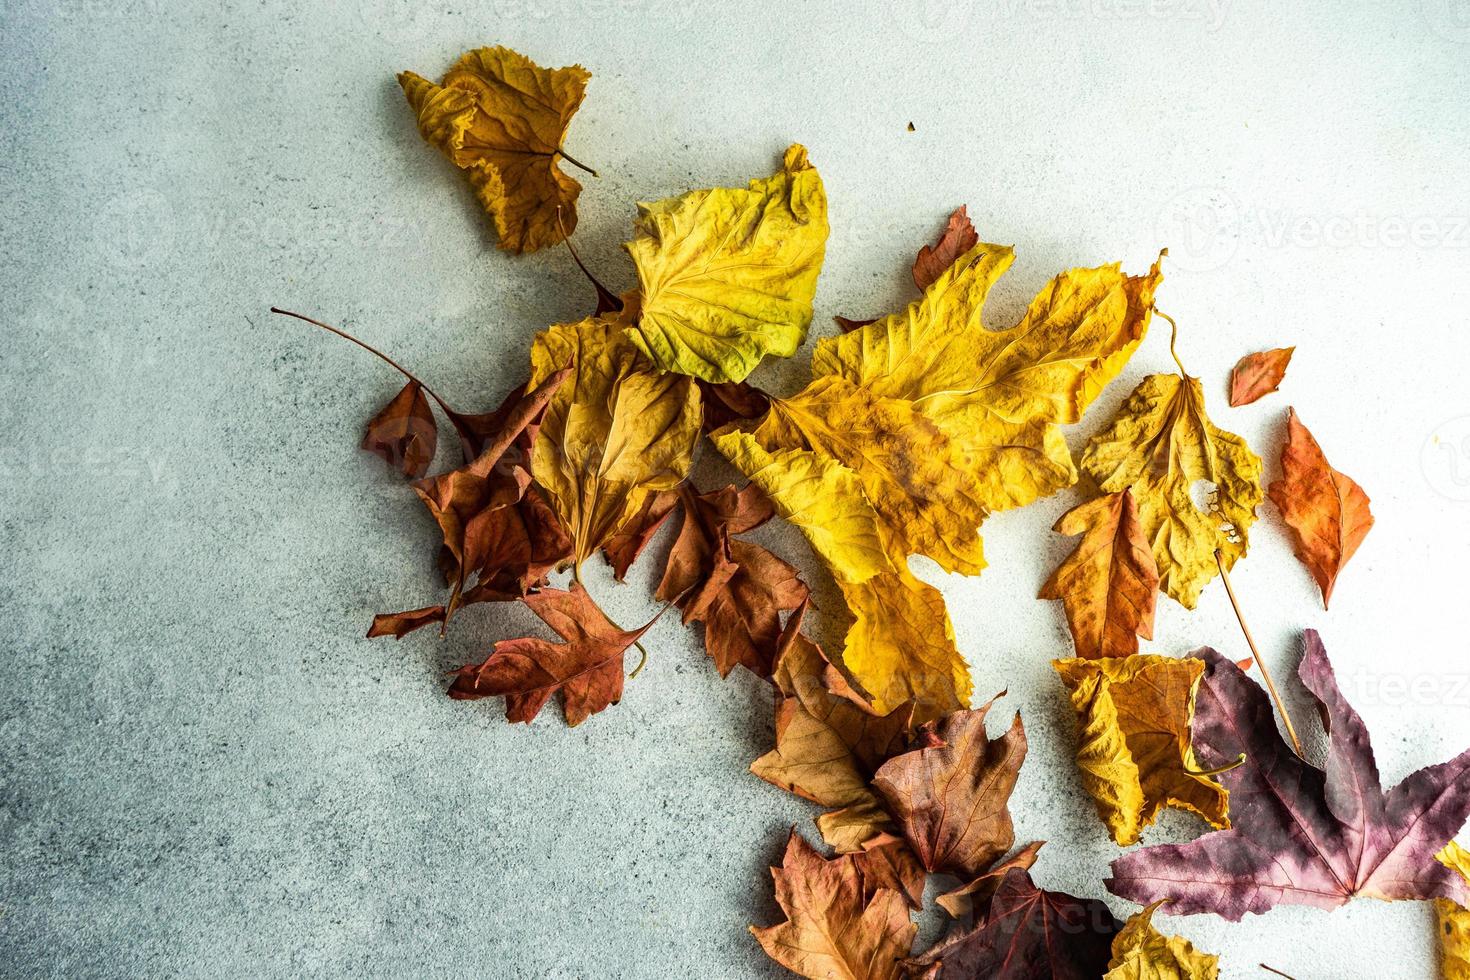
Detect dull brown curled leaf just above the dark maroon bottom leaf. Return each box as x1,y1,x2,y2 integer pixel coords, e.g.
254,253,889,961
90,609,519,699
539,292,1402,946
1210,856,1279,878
873,699,1026,877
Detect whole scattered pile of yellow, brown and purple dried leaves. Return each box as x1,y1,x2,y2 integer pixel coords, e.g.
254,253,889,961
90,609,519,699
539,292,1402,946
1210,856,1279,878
283,48,1470,980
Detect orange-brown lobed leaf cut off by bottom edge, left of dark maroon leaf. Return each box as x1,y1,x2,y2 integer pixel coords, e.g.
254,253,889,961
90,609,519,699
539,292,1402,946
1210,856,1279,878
750,830,917,980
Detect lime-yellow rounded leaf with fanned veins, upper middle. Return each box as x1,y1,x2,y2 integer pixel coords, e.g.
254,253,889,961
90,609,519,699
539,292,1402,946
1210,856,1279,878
628,145,828,382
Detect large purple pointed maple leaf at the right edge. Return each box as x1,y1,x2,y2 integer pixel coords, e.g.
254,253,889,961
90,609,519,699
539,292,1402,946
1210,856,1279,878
1105,630,1470,921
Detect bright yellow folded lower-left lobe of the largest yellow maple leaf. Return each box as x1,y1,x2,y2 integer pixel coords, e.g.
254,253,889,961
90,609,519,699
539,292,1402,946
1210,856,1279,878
710,429,892,583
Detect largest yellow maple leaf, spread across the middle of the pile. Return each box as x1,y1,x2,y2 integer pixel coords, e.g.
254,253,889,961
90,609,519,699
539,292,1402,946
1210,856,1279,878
714,244,1161,720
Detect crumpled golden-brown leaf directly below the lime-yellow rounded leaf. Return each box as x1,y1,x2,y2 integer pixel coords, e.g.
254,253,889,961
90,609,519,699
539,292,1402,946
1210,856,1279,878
531,304,700,566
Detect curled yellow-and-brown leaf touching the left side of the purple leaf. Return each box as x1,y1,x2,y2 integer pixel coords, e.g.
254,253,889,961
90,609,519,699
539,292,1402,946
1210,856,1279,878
1053,654,1230,846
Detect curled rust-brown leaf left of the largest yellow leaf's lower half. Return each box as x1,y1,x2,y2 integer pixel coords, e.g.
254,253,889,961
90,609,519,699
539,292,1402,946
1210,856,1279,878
656,483,807,677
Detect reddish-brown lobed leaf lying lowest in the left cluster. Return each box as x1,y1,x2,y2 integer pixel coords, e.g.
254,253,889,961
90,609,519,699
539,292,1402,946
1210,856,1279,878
450,583,653,726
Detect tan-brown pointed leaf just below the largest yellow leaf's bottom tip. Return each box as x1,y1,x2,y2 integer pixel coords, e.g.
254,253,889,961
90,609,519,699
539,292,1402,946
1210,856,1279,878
750,602,913,852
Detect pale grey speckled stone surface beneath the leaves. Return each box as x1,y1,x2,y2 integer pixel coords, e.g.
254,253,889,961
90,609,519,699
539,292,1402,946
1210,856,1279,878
0,0,1470,980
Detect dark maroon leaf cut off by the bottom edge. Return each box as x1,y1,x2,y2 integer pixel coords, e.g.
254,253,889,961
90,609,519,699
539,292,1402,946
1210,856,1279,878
904,868,1122,980
